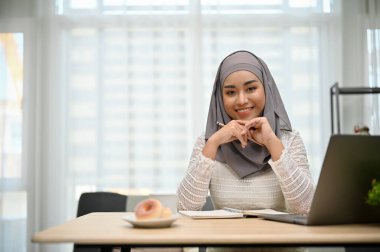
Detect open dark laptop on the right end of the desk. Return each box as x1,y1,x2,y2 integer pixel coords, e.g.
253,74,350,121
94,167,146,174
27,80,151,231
260,135,380,225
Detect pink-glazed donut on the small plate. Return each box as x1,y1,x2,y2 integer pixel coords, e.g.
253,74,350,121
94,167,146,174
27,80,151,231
135,199,163,220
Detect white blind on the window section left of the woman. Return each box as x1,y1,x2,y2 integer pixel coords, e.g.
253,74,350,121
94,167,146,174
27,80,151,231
66,25,189,190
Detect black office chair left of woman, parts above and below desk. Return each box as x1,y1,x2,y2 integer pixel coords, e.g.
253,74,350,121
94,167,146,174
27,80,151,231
74,192,130,252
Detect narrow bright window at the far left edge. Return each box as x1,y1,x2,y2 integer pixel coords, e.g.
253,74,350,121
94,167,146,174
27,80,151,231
0,32,27,251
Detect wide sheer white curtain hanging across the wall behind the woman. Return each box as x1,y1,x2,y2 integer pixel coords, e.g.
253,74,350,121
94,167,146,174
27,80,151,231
0,0,340,251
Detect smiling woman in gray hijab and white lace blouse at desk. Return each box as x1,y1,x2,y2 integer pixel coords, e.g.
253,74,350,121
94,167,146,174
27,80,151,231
177,51,314,214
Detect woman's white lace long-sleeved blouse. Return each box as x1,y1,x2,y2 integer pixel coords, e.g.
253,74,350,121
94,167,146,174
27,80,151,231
177,130,314,213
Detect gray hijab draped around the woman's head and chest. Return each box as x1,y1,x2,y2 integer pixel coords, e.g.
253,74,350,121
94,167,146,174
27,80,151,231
205,51,292,178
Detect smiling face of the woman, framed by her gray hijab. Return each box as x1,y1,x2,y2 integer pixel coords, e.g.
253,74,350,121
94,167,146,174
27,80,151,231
222,70,265,121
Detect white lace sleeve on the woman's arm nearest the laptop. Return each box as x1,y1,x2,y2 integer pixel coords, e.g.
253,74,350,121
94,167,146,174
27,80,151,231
269,132,314,214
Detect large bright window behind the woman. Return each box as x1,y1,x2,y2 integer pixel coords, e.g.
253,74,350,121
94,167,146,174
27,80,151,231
51,0,336,203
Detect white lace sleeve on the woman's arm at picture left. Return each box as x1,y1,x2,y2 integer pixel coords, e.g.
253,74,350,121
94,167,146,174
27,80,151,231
177,137,215,210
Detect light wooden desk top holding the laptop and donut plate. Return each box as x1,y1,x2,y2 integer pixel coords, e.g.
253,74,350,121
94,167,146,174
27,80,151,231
32,213,380,247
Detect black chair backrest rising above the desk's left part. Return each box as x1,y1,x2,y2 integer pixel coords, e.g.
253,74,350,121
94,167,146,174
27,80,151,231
77,192,127,217
